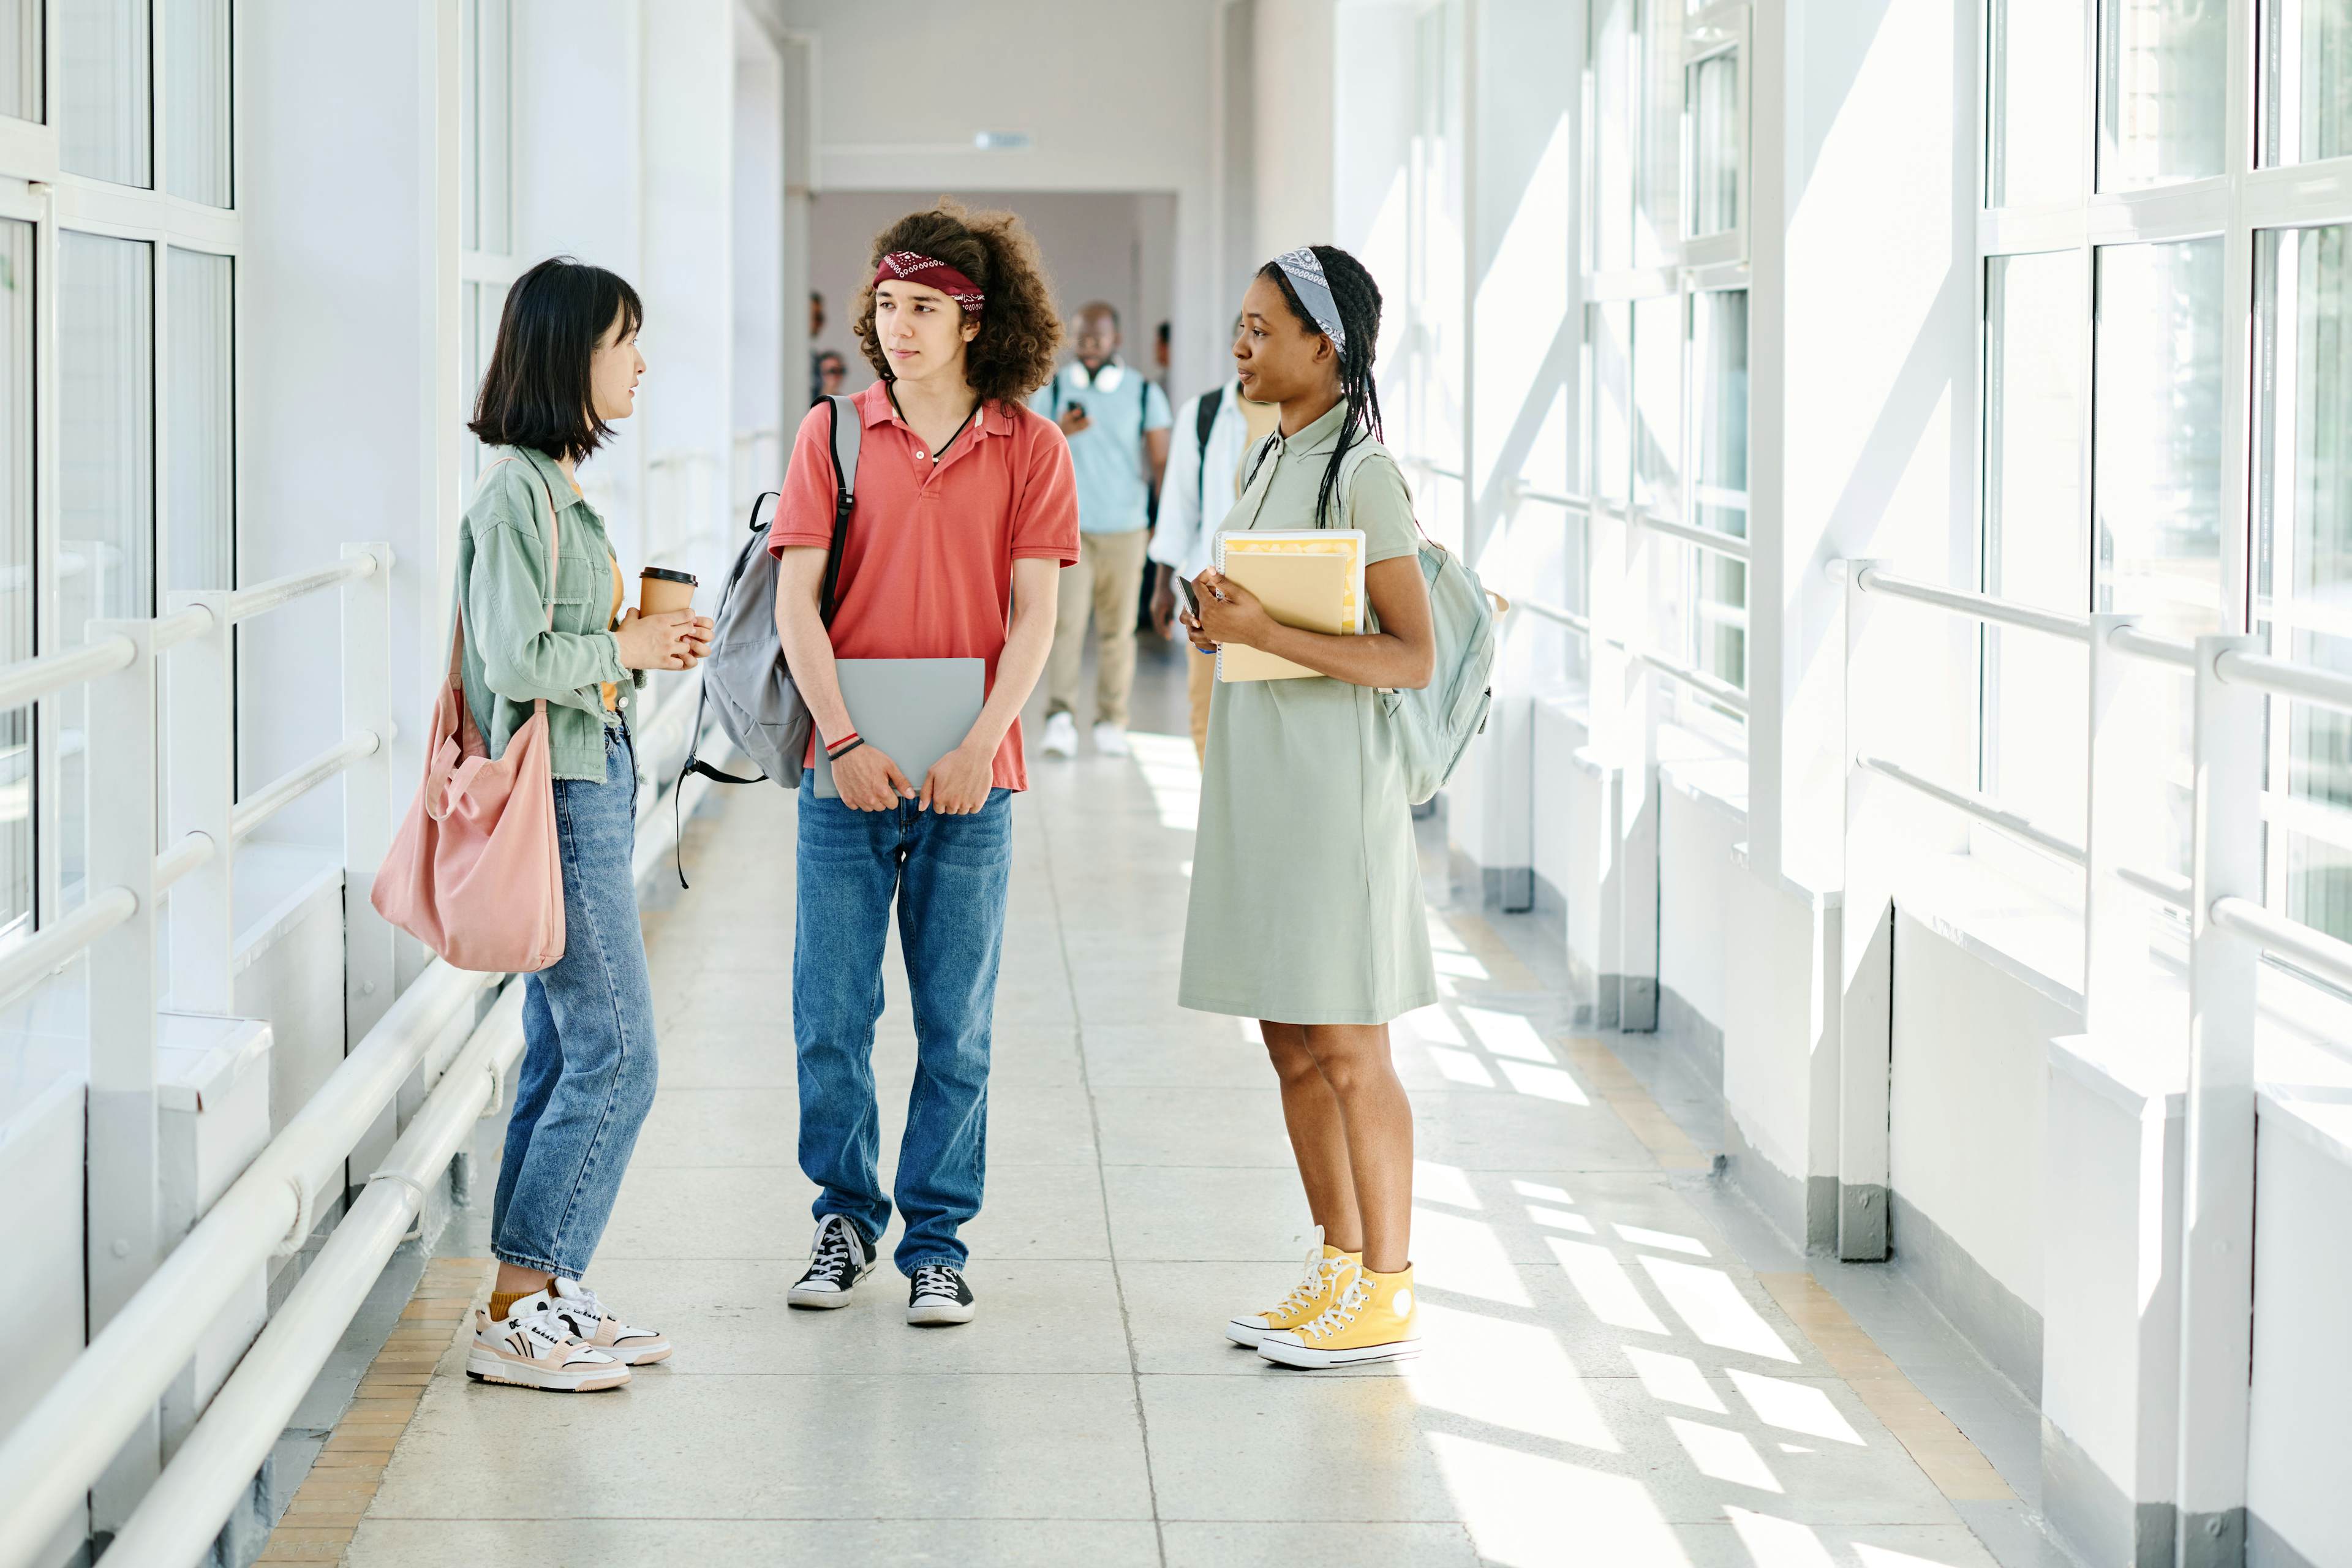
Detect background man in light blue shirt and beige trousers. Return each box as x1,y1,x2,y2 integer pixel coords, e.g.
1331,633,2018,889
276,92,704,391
1030,301,1169,757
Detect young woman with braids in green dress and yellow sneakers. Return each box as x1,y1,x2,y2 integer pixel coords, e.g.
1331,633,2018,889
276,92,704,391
1178,244,1437,1368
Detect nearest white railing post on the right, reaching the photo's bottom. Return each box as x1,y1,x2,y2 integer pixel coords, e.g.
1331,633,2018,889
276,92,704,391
2176,637,2265,1568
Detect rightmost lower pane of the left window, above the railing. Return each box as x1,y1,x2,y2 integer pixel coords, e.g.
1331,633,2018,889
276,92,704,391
167,249,238,590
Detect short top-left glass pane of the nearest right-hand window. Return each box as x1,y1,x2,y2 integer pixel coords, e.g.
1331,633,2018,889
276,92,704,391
1985,0,2084,207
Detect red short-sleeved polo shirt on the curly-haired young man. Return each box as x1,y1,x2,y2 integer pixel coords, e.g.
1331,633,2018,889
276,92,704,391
767,381,1077,790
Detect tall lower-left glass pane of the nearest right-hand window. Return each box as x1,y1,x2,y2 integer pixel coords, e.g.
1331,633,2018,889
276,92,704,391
1983,252,2091,842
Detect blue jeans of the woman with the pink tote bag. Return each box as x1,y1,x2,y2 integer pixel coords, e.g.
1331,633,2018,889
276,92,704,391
489,729,656,1279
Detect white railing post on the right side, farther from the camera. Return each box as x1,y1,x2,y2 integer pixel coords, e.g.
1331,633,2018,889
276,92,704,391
1837,559,1896,1262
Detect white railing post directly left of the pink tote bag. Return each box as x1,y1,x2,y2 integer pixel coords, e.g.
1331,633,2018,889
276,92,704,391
341,541,395,1051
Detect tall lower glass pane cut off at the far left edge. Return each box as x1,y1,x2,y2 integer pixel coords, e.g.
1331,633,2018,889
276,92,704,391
0,221,36,943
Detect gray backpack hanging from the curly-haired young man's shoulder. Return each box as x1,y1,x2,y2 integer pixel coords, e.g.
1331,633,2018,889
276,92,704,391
677,395,863,884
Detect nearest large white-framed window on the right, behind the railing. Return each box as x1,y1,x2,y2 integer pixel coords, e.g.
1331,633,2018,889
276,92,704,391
1978,0,2352,936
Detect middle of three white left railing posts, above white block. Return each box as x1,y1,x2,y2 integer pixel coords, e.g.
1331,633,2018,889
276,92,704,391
157,590,238,1018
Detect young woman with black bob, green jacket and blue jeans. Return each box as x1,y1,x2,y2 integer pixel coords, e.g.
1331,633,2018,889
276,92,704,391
456,256,710,1392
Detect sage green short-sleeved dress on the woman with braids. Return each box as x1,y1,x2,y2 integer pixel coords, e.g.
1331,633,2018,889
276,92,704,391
1176,404,1437,1023
